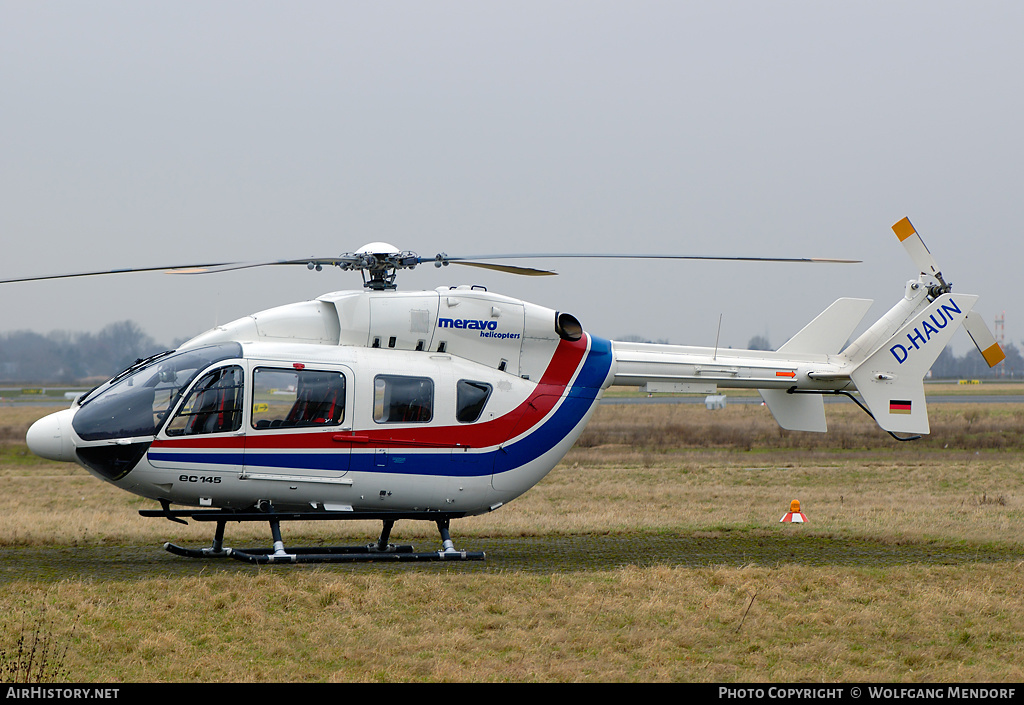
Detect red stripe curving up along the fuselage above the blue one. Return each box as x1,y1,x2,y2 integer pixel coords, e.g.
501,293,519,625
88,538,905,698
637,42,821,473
152,335,589,450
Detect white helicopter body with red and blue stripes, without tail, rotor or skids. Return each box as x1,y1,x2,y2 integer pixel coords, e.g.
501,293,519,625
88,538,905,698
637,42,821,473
29,289,612,515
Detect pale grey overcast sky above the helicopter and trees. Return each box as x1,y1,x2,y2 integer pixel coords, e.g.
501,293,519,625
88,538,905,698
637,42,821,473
0,0,1024,354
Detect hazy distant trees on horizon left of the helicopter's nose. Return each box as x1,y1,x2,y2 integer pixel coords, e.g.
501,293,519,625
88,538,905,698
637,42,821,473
0,321,168,384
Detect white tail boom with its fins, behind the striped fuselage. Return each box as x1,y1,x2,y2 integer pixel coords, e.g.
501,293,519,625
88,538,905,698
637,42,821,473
609,294,978,433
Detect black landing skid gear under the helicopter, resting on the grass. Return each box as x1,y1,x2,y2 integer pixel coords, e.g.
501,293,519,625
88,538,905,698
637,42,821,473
139,505,486,564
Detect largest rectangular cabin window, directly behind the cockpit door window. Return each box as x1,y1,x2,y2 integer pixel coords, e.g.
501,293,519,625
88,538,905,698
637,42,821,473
252,368,345,428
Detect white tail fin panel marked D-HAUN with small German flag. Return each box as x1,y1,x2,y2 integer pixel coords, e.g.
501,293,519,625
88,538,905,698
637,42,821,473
850,294,978,433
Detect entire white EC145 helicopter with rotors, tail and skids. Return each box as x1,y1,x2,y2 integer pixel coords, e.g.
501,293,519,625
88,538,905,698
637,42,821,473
6,218,1005,564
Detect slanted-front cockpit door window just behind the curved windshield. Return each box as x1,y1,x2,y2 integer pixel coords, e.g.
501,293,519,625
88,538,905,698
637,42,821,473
167,365,243,436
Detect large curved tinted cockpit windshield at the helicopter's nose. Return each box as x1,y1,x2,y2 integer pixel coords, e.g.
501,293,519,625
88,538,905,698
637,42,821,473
72,342,242,441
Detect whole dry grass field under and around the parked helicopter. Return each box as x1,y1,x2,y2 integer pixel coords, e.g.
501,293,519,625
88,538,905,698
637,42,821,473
0,404,1024,682
